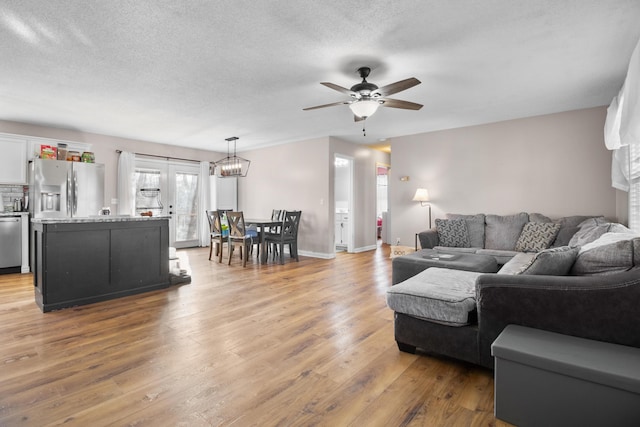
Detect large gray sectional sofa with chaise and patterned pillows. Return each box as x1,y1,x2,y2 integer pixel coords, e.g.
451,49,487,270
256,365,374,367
387,213,640,368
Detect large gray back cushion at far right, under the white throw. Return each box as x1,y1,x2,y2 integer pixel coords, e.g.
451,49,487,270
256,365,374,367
571,233,638,276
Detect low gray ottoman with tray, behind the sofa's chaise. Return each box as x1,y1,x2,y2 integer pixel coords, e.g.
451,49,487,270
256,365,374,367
392,249,498,285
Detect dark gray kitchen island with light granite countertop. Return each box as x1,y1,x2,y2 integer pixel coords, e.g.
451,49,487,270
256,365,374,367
32,216,170,312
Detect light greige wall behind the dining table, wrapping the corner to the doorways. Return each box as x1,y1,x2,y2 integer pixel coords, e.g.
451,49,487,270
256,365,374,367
239,137,389,258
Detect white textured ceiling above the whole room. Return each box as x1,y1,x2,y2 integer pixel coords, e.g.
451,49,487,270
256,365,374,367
0,0,640,151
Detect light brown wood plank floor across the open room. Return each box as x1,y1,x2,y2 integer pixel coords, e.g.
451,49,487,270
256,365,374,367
0,245,508,426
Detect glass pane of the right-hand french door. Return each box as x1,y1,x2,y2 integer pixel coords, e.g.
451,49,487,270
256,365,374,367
175,172,198,241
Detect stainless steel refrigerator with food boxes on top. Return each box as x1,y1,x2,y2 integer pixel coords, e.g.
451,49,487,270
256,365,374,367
29,159,105,218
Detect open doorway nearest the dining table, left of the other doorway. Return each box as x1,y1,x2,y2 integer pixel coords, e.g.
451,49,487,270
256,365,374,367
333,154,353,252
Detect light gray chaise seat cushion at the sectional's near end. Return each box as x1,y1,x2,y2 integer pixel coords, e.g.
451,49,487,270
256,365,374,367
387,267,483,326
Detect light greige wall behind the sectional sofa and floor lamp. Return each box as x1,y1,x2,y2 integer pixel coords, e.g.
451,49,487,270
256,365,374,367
389,107,624,246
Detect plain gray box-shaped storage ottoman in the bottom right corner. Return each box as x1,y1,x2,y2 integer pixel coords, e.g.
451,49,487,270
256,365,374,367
491,325,640,427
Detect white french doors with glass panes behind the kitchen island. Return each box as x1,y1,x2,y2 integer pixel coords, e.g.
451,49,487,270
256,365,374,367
136,159,201,248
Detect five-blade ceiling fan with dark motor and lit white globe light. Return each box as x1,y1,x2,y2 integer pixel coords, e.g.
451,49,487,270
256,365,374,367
303,67,422,122
